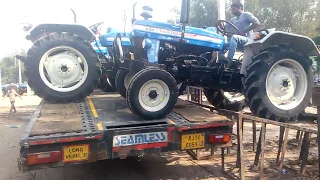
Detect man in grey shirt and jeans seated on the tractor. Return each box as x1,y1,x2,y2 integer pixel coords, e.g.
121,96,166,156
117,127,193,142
225,2,260,67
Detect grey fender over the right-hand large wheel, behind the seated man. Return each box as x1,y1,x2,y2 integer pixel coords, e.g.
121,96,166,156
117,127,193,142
240,31,320,75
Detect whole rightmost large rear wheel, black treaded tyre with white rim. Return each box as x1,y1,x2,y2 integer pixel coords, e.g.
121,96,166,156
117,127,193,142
244,45,313,122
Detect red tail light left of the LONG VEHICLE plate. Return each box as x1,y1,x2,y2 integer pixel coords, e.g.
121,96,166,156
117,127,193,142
27,151,61,165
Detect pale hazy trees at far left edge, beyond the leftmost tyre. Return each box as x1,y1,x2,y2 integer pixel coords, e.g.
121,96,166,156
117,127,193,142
0,50,26,84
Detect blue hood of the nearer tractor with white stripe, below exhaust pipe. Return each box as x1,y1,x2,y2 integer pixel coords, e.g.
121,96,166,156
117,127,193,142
131,20,225,49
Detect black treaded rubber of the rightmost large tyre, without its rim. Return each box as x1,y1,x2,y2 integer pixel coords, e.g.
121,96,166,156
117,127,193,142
244,44,312,122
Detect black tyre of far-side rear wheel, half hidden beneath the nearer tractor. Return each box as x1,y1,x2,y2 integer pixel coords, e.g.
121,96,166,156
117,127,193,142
203,89,245,111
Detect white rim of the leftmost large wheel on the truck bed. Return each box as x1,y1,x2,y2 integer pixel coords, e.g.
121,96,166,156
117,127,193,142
39,46,88,92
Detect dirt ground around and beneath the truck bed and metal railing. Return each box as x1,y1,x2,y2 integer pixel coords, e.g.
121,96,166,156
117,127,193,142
0,96,318,180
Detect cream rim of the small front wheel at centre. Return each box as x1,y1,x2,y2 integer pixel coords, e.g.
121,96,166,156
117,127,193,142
139,79,170,112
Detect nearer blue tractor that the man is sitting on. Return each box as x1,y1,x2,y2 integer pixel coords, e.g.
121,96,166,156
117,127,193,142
113,0,319,122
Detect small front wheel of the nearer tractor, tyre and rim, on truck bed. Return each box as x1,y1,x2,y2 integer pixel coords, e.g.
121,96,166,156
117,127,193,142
127,69,178,120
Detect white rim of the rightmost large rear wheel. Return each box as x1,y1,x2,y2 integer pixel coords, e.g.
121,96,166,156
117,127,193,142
266,59,308,110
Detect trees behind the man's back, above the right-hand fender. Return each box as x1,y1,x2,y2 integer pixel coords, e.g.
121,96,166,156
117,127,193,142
245,0,320,37
